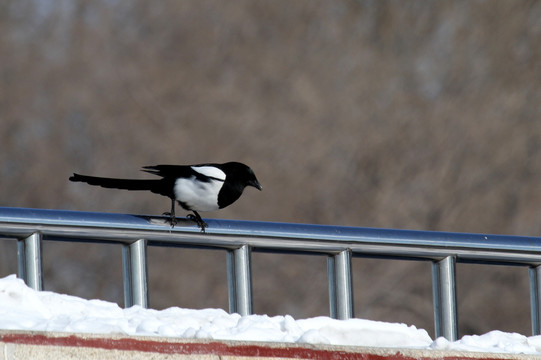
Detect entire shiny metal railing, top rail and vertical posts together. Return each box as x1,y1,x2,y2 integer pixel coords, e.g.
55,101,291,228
0,207,541,340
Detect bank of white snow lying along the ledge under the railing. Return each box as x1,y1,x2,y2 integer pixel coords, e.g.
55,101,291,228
0,275,541,354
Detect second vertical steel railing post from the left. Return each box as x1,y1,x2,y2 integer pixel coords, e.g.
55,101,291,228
122,239,148,308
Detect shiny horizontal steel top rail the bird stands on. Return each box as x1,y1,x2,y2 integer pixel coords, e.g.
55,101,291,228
0,207,541,265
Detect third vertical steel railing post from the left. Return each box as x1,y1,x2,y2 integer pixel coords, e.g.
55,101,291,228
227,245,253,316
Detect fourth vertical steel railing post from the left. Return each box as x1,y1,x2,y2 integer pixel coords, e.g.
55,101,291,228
327,250,354,320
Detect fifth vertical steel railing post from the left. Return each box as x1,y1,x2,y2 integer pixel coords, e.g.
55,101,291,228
432,256,458,341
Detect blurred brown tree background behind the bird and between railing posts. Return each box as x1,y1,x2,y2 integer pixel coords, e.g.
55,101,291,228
0,0,541,335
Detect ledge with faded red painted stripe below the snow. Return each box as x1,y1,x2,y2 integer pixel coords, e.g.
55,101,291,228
0,331,541,360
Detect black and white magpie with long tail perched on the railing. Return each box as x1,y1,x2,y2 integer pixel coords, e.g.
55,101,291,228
69,162,262,232
